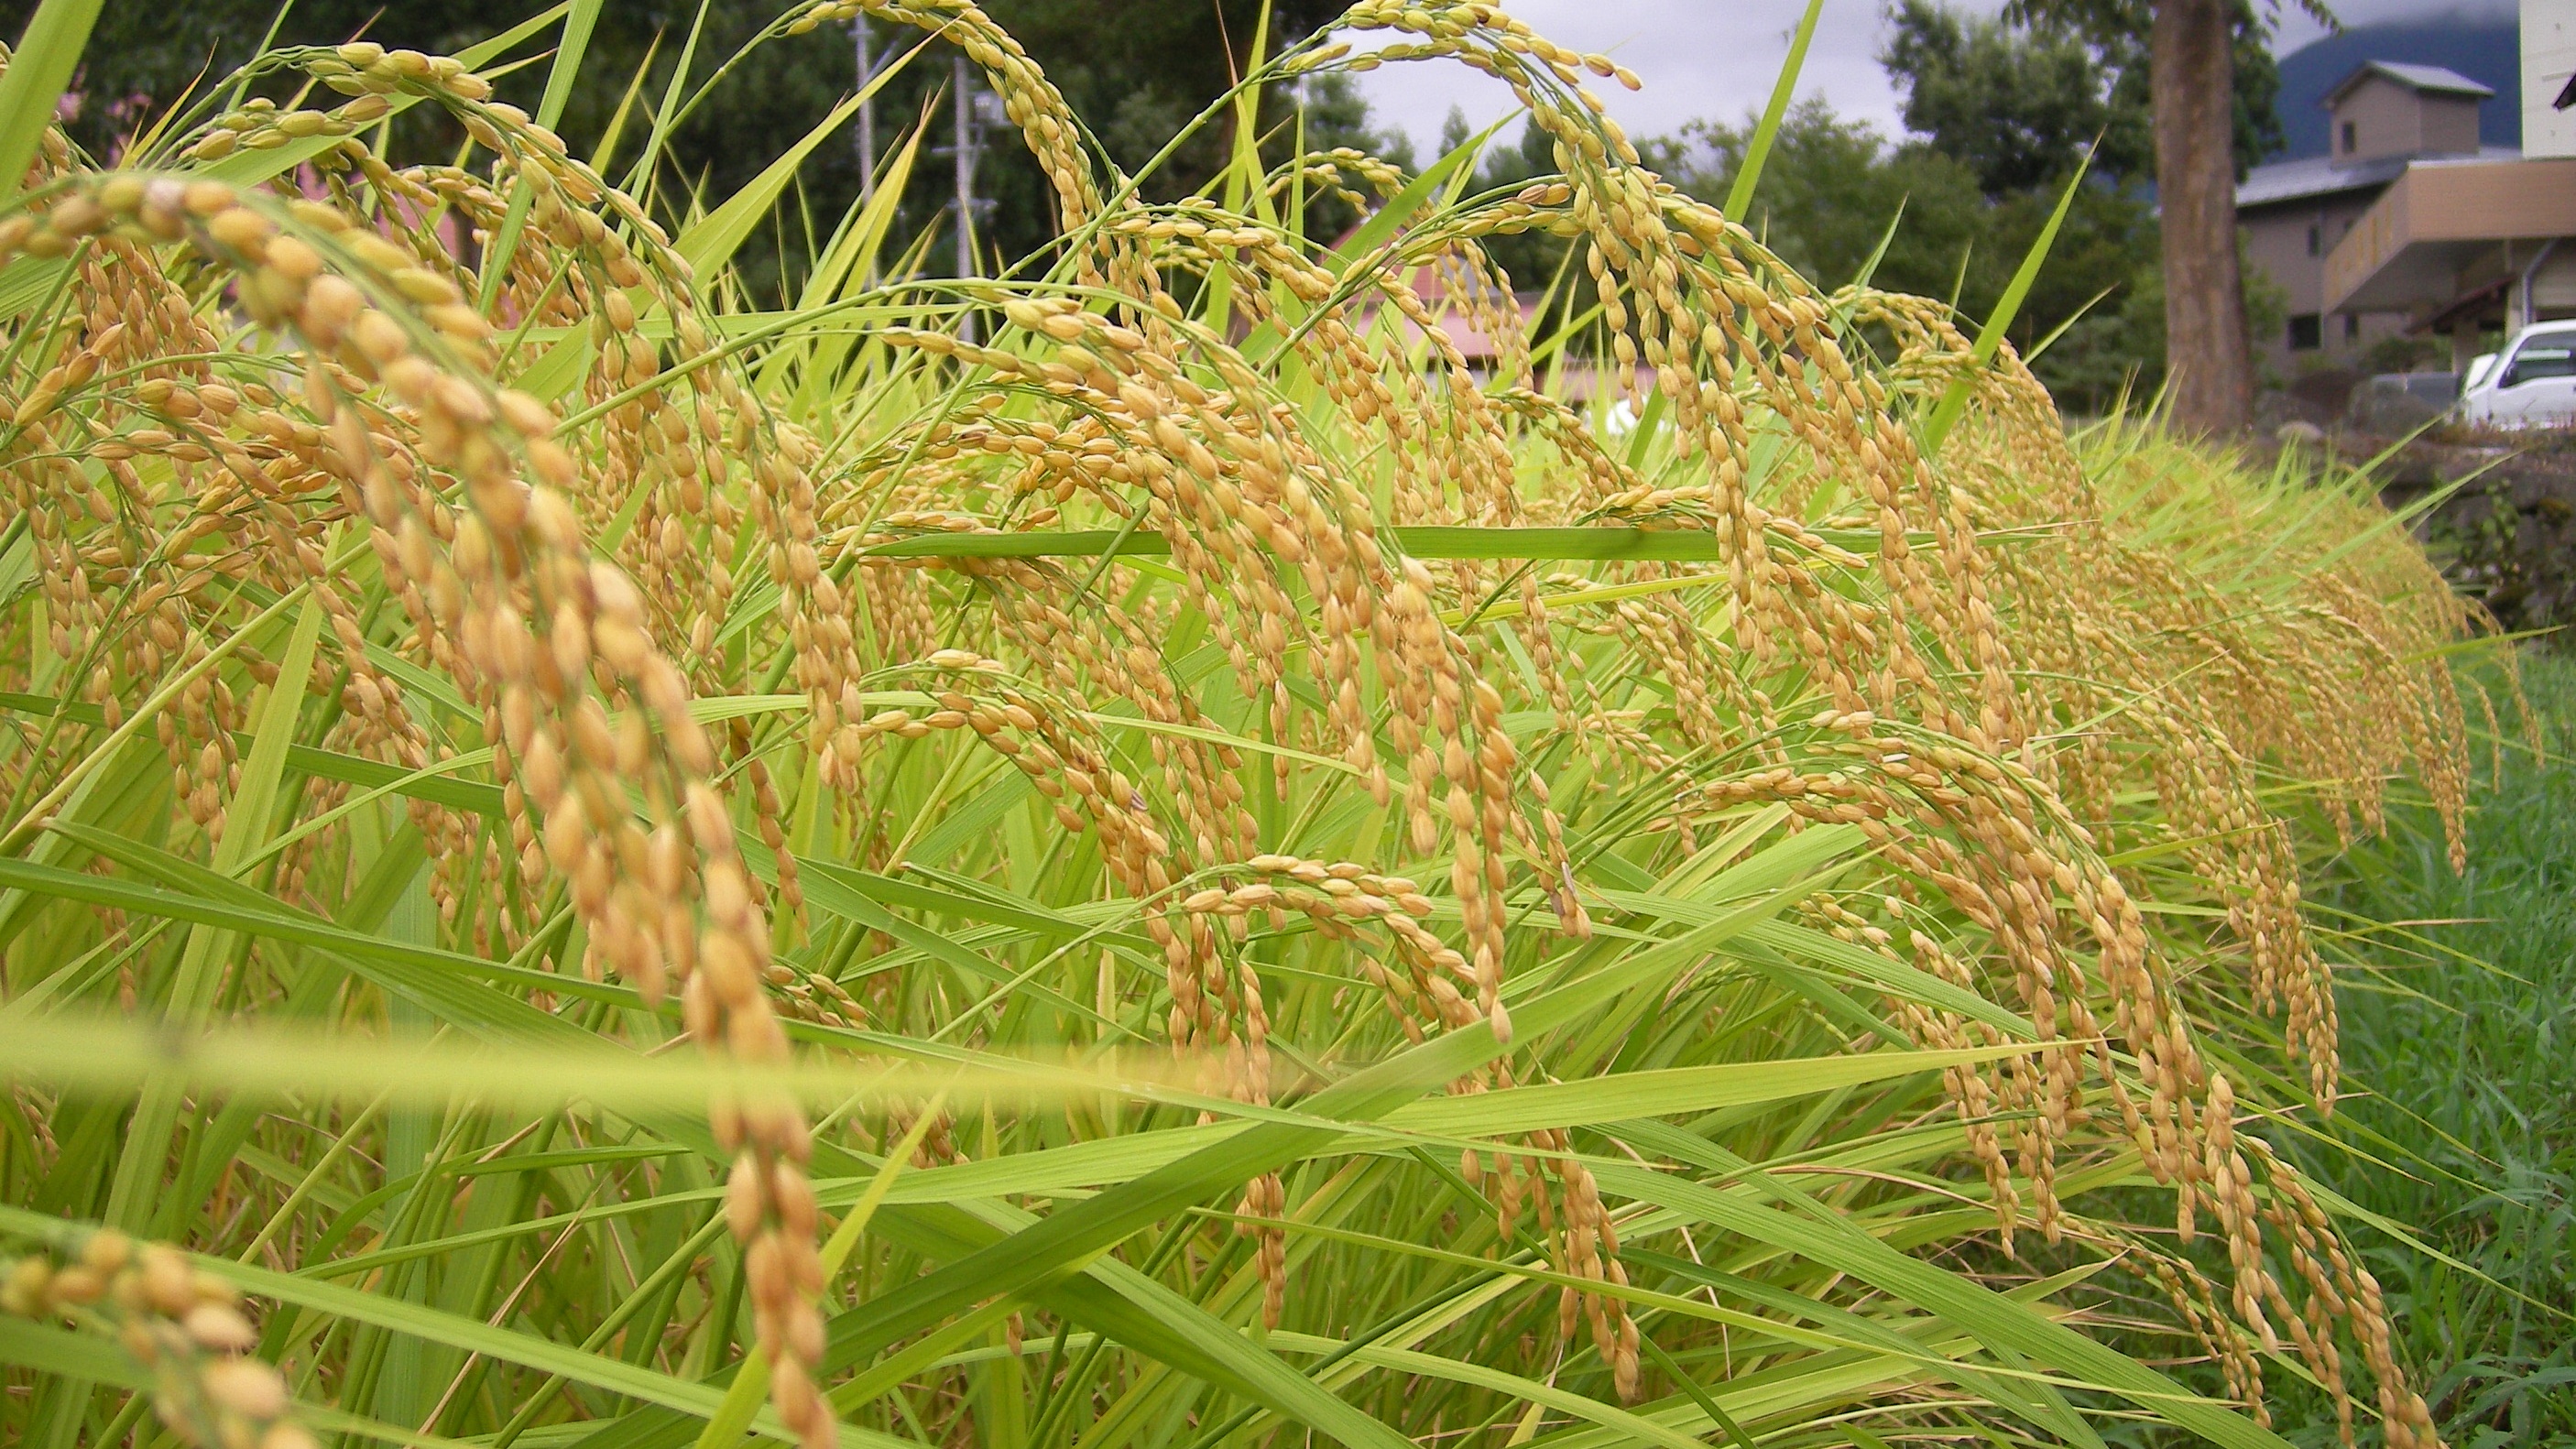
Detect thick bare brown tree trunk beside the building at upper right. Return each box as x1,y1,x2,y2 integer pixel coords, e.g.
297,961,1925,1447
2151,0,2254,438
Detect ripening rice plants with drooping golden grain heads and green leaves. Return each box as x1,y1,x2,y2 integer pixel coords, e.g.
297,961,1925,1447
0,0,2509,1449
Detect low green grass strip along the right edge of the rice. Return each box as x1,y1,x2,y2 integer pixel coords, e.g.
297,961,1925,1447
2306,654,2576,1449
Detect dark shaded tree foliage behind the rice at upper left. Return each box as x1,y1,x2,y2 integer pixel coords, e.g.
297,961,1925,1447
0,0,1386,304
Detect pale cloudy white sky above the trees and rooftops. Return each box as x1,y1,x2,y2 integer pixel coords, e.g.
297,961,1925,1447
1360,0,2512,149
